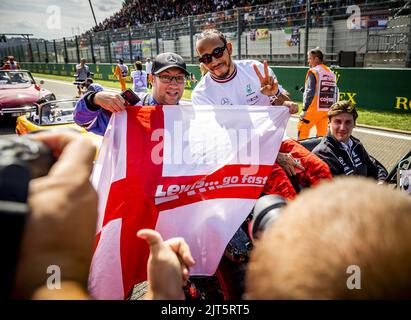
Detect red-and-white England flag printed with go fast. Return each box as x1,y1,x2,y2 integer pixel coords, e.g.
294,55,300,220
89,105,290,299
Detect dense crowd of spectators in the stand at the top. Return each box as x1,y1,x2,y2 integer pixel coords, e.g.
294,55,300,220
90,0,387,32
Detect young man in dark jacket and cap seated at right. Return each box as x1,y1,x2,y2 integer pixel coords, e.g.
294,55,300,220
313,101,388,183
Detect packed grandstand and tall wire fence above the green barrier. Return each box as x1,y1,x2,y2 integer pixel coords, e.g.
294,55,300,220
0,0,411,67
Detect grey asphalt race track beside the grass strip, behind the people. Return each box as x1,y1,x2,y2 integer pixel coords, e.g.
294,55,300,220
0,78,411,170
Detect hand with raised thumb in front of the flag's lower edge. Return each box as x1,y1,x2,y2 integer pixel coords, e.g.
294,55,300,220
137,229,195,300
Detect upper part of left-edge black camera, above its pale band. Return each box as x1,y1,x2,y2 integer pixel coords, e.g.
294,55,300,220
0,137,55,202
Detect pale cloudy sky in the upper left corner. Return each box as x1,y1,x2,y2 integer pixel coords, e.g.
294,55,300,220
0,0,122,40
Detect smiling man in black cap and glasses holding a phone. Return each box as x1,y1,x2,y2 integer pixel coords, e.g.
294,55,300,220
74,52,188,135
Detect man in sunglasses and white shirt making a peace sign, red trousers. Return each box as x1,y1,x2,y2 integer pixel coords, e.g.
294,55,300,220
191,30,331,199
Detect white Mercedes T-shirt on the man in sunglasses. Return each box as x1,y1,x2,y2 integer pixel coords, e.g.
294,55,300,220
191,60,283,106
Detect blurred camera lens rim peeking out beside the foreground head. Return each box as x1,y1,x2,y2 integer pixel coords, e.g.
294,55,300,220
249,194,287,240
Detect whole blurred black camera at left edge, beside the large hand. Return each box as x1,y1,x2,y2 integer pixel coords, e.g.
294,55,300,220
0,137,55,299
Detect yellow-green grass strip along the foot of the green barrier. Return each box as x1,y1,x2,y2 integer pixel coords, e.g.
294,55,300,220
33,73,411,132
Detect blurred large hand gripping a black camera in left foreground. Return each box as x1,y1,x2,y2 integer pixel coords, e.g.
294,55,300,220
1,133,97,299
